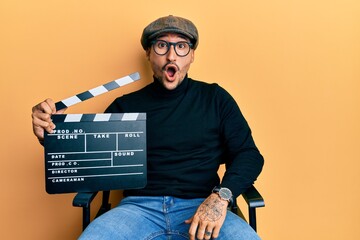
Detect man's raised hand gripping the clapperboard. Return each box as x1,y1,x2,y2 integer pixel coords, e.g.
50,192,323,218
31,98,66,141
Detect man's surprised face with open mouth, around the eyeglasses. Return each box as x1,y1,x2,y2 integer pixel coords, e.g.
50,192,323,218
146,33,194,90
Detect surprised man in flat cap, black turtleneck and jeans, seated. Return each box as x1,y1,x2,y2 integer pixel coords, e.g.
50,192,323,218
33,15,263,240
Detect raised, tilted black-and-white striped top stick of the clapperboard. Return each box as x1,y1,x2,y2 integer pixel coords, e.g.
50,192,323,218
55,72,140,111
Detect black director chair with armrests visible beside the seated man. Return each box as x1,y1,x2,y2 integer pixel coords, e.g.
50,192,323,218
73,186,265,231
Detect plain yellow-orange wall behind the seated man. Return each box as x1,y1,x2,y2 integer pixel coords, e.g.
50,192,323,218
0,0,360,240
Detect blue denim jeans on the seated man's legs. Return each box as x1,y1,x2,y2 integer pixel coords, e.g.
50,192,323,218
79,196,260,240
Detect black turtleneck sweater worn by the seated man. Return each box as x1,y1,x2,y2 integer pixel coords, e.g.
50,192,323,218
106,77,263,198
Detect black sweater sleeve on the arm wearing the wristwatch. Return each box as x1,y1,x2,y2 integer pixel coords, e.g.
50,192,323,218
218,87,264,197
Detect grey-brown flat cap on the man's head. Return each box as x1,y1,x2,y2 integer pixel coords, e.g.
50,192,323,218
141,15,199,50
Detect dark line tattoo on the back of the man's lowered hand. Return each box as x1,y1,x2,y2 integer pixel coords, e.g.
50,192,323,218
198,196,224,222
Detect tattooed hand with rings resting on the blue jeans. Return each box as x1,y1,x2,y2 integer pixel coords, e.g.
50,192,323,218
185,193,229,240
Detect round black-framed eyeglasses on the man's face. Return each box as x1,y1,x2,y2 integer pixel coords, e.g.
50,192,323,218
151,40,193,57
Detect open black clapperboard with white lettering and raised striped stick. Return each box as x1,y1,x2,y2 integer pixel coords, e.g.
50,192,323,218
44,73,147,194
